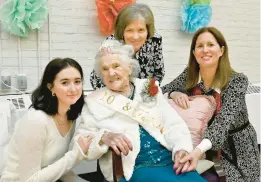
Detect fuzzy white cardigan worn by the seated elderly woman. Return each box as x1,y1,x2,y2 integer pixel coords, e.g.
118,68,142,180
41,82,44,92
75,79,193,181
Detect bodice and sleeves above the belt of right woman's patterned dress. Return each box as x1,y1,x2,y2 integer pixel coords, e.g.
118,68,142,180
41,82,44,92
162,68,248,150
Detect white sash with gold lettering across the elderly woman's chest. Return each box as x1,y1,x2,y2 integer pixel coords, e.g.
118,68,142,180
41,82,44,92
91,88,163,132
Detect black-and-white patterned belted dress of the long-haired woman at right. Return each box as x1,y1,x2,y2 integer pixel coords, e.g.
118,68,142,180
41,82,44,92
162,68,260,182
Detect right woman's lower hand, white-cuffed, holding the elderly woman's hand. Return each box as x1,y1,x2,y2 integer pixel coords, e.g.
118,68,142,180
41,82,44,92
180,147,203,172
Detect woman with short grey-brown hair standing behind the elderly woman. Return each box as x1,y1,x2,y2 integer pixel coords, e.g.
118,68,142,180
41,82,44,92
90,4,162,90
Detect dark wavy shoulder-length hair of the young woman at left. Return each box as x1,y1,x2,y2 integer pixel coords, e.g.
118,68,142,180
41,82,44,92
30,58,84,120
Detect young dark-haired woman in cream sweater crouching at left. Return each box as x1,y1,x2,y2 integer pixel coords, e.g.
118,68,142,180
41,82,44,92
0,58,91,182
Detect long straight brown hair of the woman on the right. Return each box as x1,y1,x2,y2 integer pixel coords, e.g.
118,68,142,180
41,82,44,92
185,27,235,90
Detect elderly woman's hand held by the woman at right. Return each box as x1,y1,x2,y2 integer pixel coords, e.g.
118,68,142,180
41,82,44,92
173,150,190,175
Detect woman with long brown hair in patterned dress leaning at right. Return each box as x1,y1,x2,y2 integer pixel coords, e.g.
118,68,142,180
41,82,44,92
162,27,260,182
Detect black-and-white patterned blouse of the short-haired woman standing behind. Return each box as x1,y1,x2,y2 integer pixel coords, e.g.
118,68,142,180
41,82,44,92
90,34,165,90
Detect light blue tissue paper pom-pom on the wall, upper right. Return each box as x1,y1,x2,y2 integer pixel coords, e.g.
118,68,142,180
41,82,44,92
181,3,212,33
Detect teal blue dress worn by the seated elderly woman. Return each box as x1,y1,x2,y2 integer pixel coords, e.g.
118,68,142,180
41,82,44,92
119,90,206,182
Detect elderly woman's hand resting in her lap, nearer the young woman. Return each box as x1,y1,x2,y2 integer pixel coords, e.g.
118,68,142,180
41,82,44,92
101,132,133,155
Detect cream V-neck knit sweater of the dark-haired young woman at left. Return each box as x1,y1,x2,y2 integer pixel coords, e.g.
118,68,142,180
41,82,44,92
0,109,83,182
